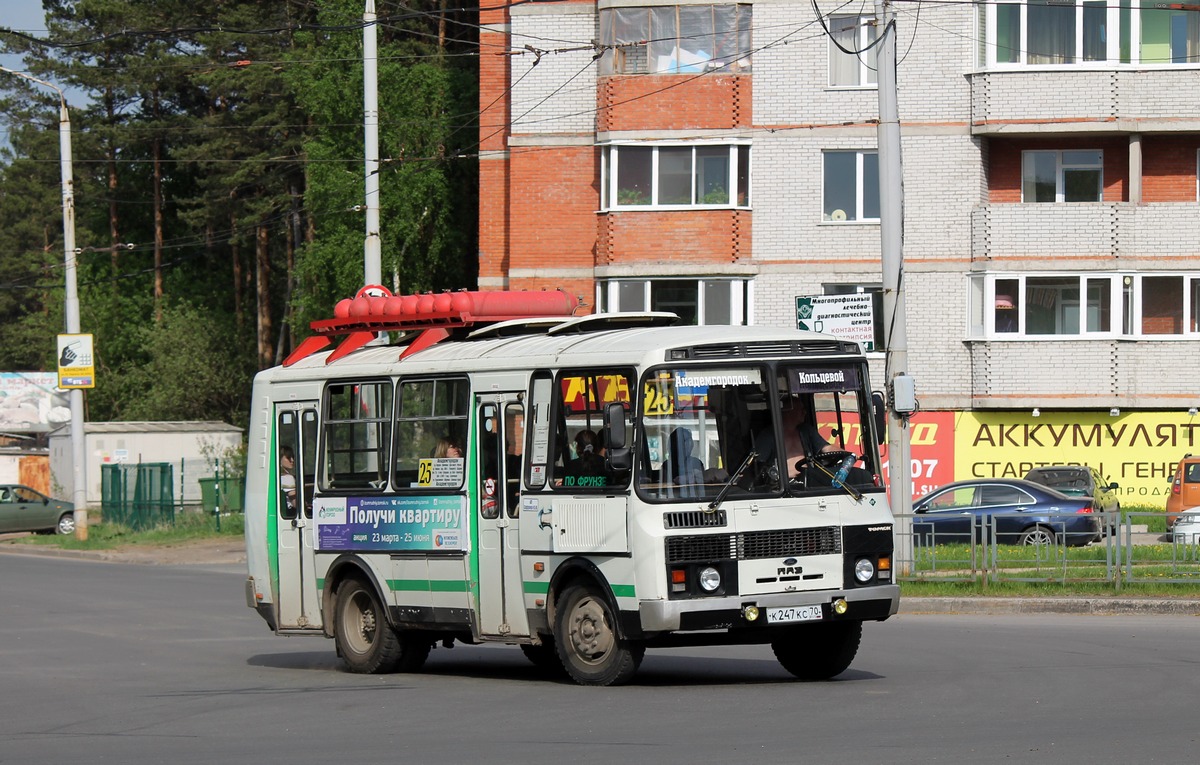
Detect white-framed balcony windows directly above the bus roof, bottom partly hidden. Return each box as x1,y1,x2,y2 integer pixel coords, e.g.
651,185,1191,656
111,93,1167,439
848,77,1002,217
596,278,750,325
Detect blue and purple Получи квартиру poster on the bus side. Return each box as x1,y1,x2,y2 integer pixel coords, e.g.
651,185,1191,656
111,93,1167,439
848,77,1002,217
313,494,467,552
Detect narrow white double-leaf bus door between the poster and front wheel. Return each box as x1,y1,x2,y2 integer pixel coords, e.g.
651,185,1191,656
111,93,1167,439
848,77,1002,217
476,393,529,636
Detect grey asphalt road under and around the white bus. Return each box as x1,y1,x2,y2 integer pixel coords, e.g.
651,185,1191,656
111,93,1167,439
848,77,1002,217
0,554,1200,765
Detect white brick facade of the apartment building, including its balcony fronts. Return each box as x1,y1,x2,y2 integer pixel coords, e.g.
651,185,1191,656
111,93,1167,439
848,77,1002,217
494,0,1200,409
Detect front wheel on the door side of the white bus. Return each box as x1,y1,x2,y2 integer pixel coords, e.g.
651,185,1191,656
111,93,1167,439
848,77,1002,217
554,584,646,686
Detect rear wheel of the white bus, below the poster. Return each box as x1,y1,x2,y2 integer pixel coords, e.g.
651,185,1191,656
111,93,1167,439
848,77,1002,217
334,579,403,675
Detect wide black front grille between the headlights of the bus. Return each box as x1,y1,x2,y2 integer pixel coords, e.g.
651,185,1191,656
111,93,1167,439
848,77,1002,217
666,526,841,564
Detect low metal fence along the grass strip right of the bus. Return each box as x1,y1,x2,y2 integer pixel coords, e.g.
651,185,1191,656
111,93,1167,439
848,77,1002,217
895,512,1200,590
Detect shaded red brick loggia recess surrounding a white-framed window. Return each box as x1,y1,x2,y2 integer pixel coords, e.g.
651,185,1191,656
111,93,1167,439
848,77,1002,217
988,134,1129,204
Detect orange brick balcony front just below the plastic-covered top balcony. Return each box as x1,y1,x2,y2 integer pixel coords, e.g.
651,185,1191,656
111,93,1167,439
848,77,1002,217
596,74,751,132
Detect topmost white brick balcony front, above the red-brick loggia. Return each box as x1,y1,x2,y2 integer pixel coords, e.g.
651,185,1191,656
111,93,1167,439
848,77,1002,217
967,66,1200,135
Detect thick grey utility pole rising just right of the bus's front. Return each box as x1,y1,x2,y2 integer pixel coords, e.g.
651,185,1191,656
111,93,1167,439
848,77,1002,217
875,0,917,574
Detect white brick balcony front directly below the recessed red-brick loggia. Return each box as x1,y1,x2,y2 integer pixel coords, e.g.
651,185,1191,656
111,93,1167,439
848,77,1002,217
971,201,1200,270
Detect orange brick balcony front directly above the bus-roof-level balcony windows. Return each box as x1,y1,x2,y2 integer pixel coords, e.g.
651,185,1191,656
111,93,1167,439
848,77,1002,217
596,210,750,265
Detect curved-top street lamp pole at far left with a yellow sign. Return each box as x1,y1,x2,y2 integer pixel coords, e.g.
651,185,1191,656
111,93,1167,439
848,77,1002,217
0,66,88,540
